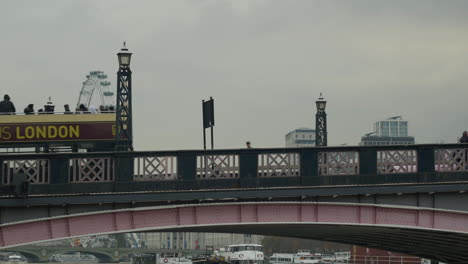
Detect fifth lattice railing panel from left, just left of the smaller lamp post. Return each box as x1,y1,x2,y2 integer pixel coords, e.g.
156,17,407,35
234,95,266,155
258,153,300,178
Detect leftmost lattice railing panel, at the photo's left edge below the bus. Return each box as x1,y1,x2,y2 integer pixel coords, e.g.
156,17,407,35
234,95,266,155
3,159,50,185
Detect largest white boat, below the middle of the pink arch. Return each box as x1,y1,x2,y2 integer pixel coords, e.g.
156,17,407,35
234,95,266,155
219,244,265,264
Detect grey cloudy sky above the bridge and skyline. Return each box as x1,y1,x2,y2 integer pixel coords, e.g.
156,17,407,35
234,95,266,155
0,0,468,150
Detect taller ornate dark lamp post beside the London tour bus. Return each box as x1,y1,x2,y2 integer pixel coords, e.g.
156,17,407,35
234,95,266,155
115,42,133,151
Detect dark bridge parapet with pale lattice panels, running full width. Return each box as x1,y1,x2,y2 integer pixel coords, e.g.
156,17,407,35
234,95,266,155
0,144,468,195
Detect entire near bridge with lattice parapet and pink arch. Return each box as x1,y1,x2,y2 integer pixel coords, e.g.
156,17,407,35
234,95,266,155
0,144,468,263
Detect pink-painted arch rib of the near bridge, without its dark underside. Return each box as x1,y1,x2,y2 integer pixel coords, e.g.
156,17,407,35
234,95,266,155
0,202,468,248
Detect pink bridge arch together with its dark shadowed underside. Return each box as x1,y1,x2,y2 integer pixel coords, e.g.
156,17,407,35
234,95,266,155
0,202,468,263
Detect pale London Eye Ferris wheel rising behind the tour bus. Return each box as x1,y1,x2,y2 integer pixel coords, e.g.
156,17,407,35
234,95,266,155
76,71,115,110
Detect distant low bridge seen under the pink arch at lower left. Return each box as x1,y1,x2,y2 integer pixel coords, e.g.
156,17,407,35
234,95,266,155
0,246,206,263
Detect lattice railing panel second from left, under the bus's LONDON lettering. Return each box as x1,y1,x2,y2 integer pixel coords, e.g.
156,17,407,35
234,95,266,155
70,158,115,183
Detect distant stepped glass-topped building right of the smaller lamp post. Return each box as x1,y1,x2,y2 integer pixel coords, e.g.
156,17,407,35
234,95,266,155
359,116,414,146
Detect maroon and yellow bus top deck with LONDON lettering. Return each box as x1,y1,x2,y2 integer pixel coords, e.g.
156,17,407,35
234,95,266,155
0,112,116,153
